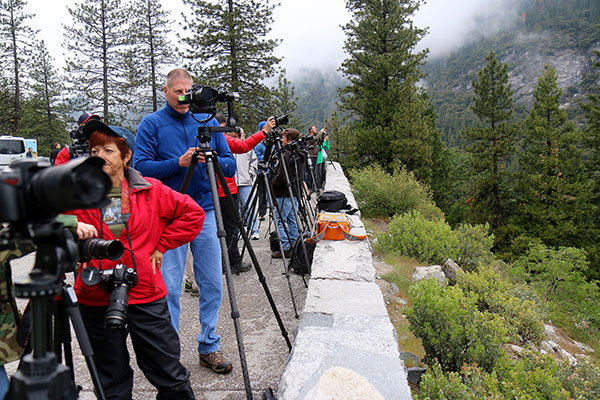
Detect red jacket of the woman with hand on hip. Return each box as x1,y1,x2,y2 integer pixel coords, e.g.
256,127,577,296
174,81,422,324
69,168,204,306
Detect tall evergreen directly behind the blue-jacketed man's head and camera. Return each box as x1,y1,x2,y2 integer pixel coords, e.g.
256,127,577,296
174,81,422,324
179,0,280,125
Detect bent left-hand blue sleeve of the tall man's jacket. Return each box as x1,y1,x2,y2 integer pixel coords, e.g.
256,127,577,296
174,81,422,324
133,118,181,179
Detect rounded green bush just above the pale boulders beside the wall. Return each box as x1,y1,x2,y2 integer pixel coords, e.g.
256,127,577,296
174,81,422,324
379,211,460,263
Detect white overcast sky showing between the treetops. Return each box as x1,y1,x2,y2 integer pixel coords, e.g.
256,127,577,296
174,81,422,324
26,0,516,75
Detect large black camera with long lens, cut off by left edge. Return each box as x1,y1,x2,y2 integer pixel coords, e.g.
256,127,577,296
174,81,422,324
0,157,112,222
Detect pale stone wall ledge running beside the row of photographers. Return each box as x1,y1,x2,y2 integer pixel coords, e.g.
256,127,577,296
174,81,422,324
278,163,412,400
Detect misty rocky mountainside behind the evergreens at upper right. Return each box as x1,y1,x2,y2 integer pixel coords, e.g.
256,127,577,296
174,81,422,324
424,0,600,146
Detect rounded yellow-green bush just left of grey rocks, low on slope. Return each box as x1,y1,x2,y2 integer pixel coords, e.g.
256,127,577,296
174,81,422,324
407,279,507,371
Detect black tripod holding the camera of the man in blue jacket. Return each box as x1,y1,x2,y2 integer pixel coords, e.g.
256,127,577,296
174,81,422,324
180,121,292,399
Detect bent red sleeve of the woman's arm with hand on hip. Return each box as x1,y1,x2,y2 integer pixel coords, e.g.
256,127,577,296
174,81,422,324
152,181,204,253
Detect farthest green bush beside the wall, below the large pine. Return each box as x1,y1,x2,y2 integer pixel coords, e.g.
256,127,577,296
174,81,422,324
350,165,442,219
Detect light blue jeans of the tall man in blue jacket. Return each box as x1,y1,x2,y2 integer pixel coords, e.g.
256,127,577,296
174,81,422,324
162,210,223,354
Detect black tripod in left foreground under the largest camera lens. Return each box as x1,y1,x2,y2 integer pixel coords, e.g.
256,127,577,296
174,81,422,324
7,222,106,400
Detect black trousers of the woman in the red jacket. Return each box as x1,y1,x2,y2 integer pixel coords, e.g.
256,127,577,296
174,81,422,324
79,298,195,400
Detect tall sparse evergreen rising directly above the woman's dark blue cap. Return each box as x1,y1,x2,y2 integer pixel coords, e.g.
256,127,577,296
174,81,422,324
63,0,128,123
